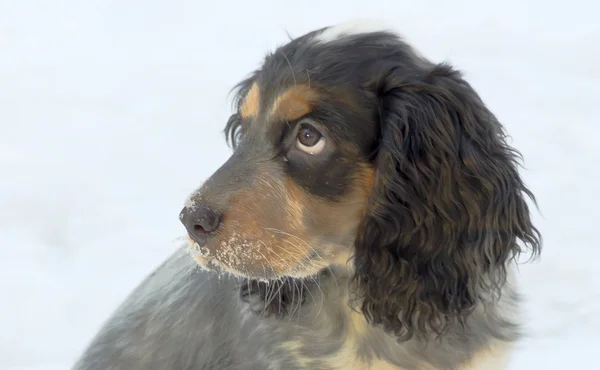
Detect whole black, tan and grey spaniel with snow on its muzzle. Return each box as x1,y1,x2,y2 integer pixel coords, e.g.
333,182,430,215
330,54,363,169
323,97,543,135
74,24,541,370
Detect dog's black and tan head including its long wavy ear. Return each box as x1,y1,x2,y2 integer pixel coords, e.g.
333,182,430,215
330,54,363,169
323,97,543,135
180,20,539,336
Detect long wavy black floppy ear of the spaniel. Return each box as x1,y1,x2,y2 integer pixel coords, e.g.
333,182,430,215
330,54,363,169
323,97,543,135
354,64,540,339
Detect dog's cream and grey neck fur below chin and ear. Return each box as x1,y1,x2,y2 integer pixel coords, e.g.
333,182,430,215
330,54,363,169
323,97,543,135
240,268,519,370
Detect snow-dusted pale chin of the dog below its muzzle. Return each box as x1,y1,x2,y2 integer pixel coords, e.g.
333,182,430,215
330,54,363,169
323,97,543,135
189,242,327,282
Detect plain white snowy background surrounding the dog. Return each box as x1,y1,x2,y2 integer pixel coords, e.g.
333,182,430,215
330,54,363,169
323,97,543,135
0,0,600,370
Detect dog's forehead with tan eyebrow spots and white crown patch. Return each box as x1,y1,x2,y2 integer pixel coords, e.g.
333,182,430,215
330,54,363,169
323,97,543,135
240,24,401,121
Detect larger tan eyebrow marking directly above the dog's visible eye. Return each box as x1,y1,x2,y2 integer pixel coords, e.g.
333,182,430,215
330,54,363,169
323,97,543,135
271,85,319,121
